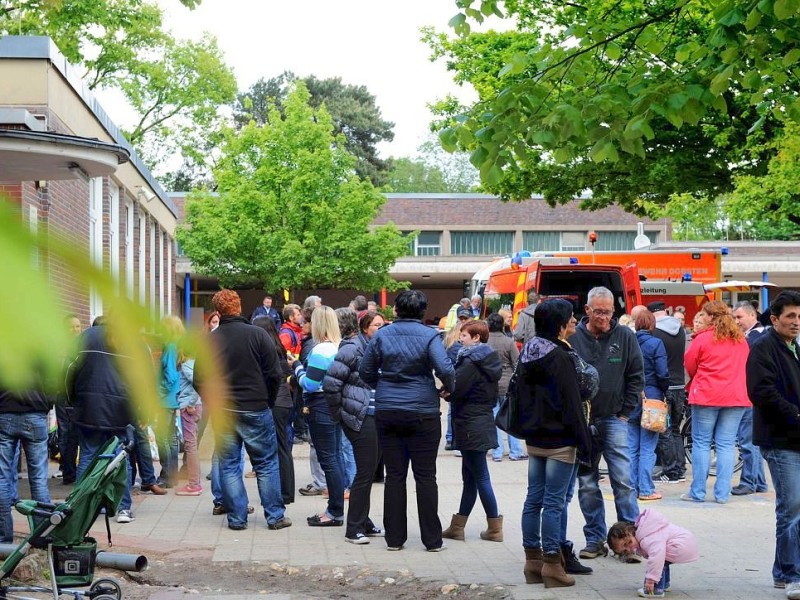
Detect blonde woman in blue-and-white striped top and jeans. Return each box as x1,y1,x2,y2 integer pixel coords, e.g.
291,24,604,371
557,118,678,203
292,306,345,527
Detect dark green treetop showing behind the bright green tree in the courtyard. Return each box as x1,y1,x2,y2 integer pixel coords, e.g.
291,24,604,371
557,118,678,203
233,71,394,187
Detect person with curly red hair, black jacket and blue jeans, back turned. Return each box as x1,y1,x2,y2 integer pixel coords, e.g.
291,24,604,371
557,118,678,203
194,290,292,530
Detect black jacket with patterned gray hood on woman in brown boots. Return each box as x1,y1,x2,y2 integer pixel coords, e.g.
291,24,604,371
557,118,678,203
517,336,591,462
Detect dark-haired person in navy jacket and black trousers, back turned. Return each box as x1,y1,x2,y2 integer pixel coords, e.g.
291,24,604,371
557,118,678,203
358,290,455,552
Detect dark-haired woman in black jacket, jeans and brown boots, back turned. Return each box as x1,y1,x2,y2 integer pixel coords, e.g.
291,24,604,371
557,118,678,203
517,299,590,587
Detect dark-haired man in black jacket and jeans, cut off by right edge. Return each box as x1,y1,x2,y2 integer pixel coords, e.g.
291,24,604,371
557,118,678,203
747,291,800,600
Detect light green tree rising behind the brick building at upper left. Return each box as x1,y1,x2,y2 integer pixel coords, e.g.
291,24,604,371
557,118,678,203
0,0,236,178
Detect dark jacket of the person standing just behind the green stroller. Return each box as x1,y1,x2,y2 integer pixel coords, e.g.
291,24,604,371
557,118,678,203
67,325,134,431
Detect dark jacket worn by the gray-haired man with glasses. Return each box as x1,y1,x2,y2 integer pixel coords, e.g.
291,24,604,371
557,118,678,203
569,317,644,418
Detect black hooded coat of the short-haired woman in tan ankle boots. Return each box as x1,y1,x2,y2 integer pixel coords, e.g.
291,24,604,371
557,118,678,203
448,344,503,452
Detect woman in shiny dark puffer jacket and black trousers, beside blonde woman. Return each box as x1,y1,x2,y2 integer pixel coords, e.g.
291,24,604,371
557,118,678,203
322,308,383,544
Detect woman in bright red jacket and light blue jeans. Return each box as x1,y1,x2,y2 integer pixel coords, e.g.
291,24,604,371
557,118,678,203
681,300,751,504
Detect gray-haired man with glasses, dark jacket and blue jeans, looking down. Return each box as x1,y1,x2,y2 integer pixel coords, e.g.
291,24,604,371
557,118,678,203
569,287,644,558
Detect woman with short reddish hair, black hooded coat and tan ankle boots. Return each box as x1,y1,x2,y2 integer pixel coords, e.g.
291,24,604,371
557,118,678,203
442,321,503,542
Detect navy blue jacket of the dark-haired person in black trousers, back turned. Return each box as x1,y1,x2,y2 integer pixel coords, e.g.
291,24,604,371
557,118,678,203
358,319,455,415
